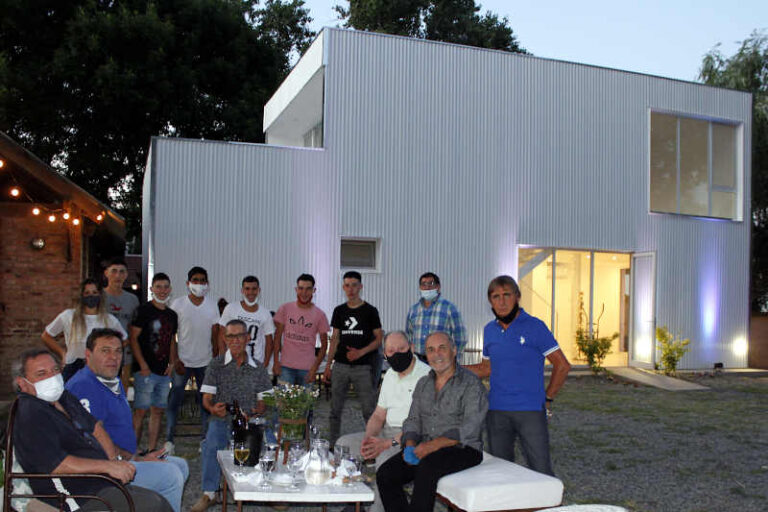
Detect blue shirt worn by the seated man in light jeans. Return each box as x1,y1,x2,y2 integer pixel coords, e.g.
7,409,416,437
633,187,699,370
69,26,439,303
66,366,136,453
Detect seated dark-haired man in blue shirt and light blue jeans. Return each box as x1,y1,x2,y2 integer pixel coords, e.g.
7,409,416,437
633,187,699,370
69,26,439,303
66,329,189,512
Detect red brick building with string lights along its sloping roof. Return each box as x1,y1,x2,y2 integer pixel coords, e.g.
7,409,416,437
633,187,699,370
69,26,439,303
0,132,125,397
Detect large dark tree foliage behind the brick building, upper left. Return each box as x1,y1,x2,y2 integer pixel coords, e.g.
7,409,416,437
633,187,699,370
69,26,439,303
0,0,314,248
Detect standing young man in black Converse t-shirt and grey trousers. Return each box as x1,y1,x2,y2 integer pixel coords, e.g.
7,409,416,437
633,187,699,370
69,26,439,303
323,271,382,446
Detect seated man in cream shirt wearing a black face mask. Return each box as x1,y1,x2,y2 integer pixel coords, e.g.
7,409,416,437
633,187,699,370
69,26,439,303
336,331,430,512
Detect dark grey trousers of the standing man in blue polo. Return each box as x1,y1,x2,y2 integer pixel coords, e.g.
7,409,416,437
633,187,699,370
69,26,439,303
485,410,555,476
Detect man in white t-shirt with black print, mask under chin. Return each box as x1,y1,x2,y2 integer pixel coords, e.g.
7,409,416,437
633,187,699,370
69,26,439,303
219,276,275,367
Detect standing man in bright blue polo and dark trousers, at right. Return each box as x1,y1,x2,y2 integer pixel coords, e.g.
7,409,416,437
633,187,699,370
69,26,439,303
468,276,571,475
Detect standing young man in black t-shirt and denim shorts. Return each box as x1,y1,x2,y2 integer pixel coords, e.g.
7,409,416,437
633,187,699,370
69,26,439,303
130,272,179,451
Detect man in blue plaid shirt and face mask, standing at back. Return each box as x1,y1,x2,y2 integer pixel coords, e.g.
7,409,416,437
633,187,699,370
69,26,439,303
405,272,467,362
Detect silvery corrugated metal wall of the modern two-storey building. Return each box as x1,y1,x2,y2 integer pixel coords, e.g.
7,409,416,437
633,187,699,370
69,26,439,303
145,30,750,367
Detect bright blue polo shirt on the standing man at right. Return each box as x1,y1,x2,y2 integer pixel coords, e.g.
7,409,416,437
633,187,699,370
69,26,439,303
483,308,560,411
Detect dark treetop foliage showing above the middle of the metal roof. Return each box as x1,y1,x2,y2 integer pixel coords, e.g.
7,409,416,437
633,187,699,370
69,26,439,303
335,0,526,53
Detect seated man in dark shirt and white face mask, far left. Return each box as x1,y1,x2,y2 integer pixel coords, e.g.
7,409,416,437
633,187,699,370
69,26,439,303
13,349,172,512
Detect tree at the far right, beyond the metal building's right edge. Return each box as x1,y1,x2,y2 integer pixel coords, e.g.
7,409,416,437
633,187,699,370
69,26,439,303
699,31,768,311
